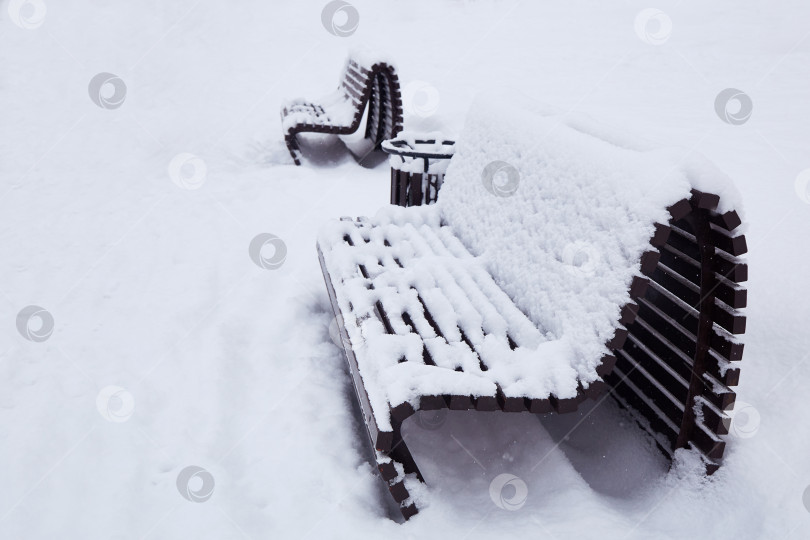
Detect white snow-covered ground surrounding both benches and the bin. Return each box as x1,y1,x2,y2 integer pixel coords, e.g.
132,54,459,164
0,0,810,539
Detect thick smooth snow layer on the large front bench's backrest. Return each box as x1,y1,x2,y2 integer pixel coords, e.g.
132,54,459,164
437,99,739,382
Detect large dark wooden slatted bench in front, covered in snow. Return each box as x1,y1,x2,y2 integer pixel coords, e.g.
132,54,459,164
318,101,747,518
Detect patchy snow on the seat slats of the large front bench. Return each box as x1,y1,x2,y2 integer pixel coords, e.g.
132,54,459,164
319,207,577,430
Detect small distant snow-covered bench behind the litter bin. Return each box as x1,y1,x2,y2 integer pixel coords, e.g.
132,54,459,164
281,52,402,165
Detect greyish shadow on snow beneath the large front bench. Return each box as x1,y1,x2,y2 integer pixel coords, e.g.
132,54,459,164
313,294,668,522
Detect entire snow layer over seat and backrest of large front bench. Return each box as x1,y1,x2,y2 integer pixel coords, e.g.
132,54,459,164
319,94,737,430
